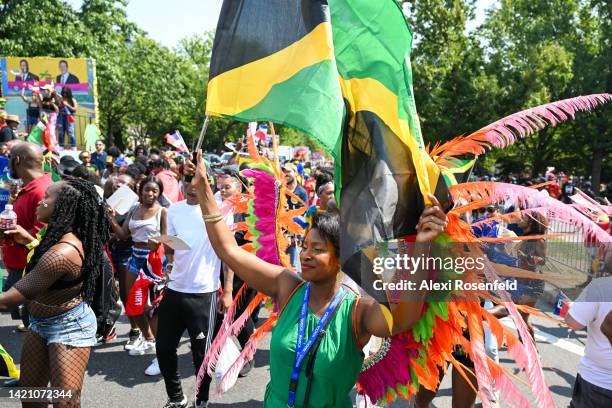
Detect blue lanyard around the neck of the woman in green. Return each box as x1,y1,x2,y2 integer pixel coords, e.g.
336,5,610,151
287,283,344,407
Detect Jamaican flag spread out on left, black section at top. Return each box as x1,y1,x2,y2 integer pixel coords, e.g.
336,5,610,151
206,0,344,158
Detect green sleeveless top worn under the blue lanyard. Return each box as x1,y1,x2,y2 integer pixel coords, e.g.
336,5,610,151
264,285,363,408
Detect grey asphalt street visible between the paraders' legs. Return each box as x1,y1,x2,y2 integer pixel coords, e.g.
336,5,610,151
0,294,586,408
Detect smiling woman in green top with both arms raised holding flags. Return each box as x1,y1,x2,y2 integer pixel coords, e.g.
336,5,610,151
186,153,446,408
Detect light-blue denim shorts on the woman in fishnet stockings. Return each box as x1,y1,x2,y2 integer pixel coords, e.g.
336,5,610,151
29,302,98,347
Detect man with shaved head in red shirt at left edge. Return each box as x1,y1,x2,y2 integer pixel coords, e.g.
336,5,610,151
2,142,53,328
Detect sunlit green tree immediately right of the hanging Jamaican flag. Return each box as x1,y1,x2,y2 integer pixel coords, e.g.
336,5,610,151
402,0,499,142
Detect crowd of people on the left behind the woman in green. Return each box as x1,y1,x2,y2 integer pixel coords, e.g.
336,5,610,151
0,135,380,407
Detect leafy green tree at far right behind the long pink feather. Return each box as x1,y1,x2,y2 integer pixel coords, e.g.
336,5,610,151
480,0,612,190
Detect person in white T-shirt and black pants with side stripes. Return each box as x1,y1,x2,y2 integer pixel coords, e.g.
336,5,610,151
157,182,231,408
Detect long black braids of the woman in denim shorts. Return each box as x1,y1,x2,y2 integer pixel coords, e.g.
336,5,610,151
26,177,110,302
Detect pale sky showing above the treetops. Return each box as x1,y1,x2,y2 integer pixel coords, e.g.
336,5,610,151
68,0,496,48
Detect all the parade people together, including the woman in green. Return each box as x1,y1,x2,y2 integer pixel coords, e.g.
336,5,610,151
0,131,612,408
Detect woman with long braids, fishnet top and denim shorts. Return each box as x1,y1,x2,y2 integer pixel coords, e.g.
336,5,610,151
0,178,110,408
